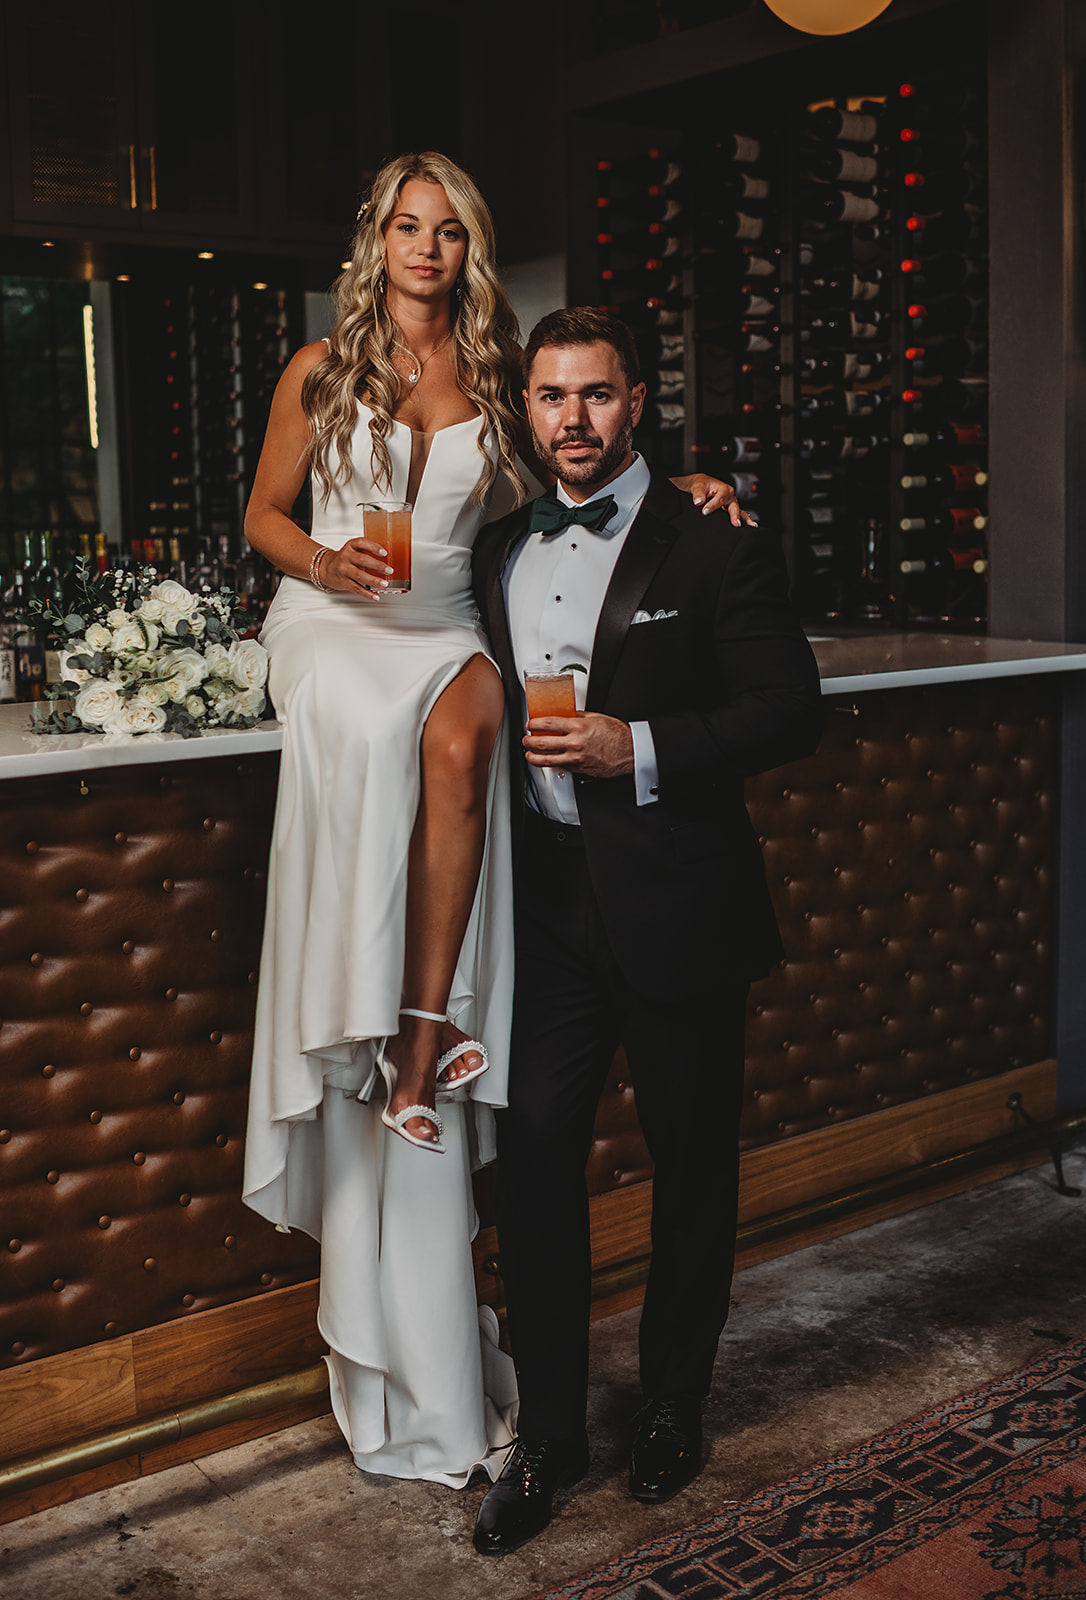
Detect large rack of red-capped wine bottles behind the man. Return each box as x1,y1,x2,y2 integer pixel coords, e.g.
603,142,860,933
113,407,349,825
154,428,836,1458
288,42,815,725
585,18,988,632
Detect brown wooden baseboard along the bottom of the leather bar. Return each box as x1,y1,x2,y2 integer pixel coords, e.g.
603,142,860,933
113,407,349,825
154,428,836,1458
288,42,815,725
0,1061,1057,1522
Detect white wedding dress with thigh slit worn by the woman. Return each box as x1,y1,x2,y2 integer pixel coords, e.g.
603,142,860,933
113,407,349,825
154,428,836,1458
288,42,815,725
245,403,517,1486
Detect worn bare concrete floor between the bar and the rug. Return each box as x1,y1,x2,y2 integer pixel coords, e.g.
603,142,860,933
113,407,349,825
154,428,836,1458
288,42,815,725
0,1146,1086,1600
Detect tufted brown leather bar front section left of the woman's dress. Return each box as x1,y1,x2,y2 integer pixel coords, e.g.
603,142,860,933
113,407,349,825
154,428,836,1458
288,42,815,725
0,755,317,1366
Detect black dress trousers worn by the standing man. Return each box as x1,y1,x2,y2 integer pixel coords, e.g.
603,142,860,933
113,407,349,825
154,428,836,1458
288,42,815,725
497,814,747,1438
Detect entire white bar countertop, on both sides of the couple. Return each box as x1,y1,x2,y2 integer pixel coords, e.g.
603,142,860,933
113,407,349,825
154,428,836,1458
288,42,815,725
0,634,1086,779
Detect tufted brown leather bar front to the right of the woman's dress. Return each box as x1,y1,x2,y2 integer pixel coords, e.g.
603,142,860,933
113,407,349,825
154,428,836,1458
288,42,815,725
589,677,1059,1194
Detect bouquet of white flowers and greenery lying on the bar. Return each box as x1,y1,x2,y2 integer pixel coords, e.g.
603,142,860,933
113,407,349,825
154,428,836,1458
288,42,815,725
32,566,267,739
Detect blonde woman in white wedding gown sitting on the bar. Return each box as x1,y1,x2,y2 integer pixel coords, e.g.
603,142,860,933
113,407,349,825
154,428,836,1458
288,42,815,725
245,154,742,1486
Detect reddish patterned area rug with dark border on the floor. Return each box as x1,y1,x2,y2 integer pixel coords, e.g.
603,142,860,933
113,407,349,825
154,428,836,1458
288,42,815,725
531,1339,1086,1600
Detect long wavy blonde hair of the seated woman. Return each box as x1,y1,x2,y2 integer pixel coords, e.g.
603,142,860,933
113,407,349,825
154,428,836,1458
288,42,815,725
302,150,528,504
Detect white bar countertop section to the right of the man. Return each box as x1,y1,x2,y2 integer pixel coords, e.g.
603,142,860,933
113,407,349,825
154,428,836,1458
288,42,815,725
811,634,1086,694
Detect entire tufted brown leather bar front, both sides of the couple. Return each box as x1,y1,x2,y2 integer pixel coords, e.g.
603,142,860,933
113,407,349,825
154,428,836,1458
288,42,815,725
0,677,1057,1388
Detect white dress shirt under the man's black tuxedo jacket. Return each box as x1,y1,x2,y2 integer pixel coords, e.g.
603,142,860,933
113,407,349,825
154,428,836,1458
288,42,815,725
502,453,657,824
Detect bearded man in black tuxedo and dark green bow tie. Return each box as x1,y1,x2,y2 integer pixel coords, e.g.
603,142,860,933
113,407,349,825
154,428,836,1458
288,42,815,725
473,309,820,1555
